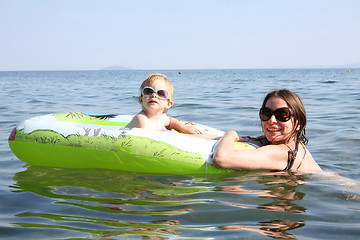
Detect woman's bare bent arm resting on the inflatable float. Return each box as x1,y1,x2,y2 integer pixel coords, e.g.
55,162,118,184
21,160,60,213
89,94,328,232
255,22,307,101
213,131,288,170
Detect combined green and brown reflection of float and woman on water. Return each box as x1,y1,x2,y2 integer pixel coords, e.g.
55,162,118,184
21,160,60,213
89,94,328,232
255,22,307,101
11,166,338,239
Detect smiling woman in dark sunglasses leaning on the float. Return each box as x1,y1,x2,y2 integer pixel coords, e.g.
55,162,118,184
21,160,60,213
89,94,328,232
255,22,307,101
213,89,322,173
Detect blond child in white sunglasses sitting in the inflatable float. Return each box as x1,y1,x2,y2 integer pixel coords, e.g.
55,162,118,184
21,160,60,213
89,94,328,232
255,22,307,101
126,73,201,134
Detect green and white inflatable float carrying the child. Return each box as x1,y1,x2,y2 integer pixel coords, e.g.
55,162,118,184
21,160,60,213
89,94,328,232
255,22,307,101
9,112,255,174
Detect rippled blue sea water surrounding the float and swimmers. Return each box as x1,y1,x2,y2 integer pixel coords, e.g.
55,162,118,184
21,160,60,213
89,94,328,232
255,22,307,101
0,69,360,239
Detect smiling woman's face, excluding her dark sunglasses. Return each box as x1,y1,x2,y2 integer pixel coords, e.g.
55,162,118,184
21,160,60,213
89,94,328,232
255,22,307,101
261,97,294,144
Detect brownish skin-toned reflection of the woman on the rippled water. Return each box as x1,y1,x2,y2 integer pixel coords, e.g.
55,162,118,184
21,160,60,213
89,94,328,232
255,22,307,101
217,172,306,239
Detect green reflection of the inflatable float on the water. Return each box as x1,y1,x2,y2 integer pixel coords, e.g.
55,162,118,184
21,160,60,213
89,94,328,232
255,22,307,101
11,166,207,239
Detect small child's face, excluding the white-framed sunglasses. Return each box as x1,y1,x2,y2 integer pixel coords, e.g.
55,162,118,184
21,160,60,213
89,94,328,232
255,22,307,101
139,79,173,112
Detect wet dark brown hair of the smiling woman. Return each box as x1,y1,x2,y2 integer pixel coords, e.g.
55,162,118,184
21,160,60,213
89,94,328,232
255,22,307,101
262,89,308,145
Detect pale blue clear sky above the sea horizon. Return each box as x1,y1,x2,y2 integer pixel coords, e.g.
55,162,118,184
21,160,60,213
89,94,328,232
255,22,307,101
0,0,360,71
